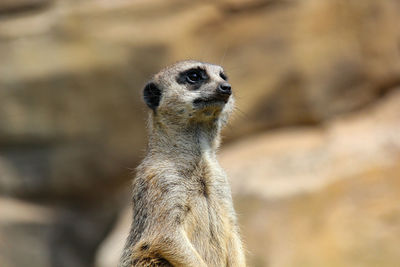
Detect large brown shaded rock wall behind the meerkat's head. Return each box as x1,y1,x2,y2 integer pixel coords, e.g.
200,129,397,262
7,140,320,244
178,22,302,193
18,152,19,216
0,0,400,198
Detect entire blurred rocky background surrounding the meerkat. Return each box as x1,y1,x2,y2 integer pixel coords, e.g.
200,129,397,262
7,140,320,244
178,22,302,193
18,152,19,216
0,0,400,267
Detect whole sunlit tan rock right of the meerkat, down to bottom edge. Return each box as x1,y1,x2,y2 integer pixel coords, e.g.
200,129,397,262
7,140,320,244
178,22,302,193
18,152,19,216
220,89,400,267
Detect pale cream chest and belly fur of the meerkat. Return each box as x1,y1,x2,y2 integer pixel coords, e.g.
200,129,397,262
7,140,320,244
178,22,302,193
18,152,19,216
184,158,234,266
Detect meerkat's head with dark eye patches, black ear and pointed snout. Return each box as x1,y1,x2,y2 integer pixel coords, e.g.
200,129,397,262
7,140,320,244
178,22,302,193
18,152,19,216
143,61,234,129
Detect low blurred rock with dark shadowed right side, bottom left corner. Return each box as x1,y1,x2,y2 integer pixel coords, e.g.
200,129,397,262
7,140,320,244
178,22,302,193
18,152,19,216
0,198,120,267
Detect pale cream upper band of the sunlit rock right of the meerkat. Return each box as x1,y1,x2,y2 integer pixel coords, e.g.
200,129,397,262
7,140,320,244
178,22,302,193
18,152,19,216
220,88,400,198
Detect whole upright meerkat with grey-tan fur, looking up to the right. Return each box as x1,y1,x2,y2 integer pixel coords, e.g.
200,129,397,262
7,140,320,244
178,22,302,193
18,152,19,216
119,61,246,267
